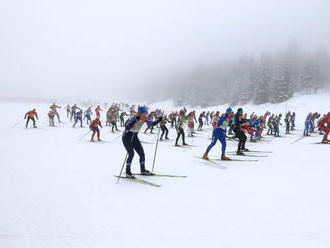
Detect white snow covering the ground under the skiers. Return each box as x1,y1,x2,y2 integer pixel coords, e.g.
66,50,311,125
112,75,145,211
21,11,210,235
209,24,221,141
0,94,330,248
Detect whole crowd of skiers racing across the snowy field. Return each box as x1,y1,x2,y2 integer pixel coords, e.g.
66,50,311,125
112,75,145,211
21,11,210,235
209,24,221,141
24,103,330,177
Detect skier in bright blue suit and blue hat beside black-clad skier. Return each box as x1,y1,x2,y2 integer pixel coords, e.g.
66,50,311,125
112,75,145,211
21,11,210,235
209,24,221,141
203,108,234,160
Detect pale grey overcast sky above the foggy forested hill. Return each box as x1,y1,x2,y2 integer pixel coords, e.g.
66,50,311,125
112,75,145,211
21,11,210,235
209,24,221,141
0,0,330,101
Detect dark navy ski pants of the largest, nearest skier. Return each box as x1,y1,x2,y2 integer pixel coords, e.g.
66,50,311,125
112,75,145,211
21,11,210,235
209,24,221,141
122,132,145,170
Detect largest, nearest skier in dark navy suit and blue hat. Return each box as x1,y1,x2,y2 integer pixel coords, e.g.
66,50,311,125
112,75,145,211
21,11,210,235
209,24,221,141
122,106,162,178
